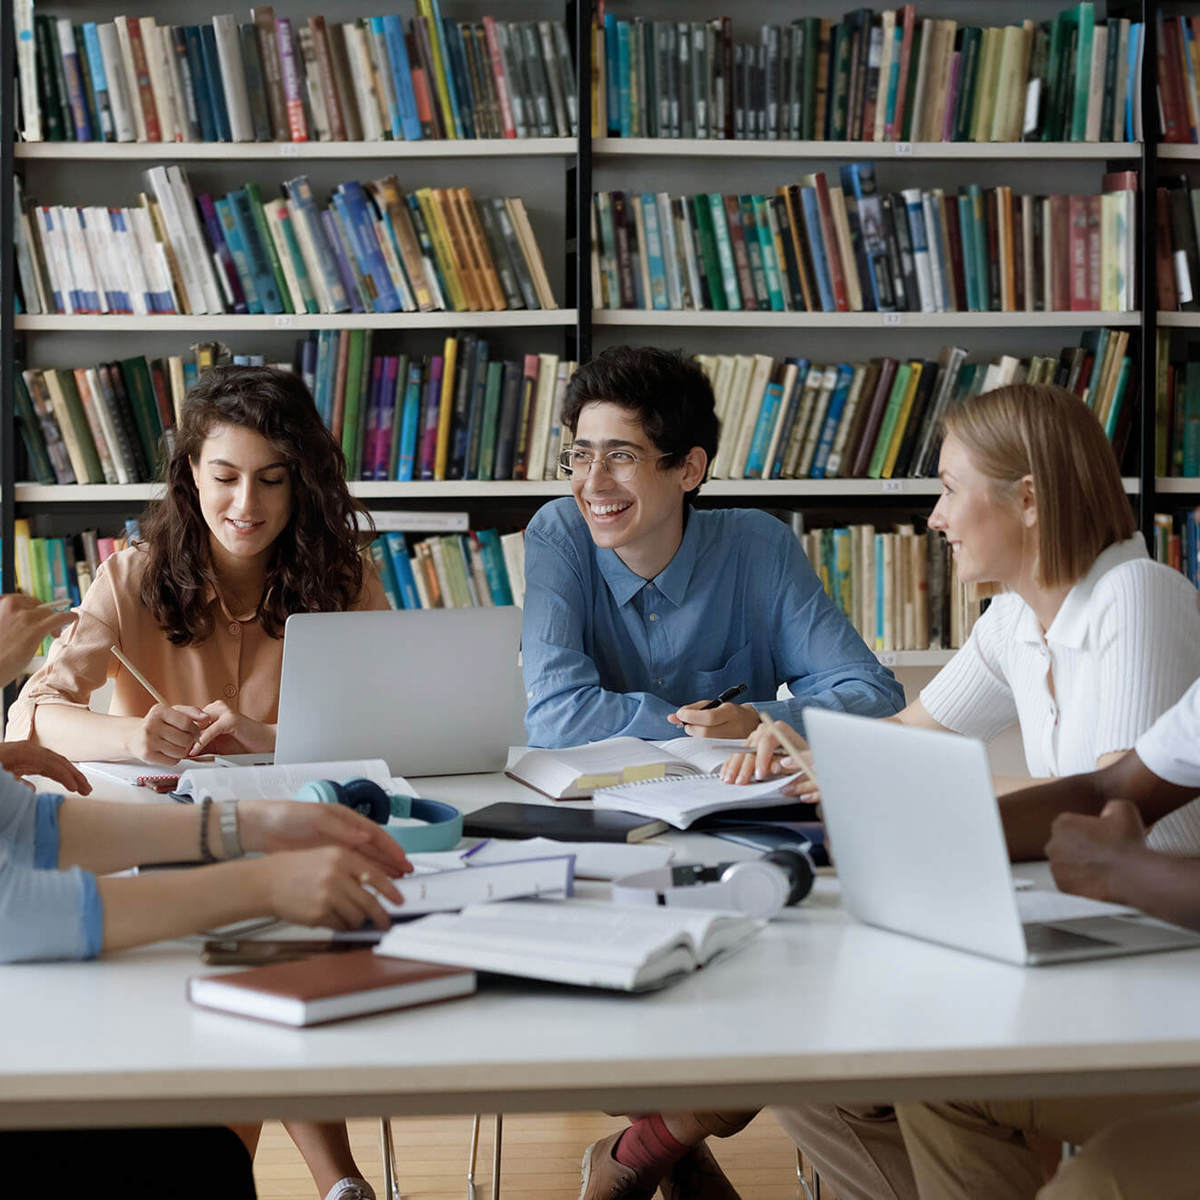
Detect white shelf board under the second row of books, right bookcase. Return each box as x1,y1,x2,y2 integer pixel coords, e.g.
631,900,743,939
592,308,1137,329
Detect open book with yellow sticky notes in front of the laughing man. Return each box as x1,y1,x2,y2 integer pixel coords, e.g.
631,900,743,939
505,738,746,800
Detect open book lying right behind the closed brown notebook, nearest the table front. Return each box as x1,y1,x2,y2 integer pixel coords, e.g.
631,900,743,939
376,900,766,991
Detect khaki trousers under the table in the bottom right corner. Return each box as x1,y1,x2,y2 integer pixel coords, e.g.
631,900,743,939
897,1096,1200,1200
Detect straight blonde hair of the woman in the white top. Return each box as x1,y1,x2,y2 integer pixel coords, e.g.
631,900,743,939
942,383,1138,588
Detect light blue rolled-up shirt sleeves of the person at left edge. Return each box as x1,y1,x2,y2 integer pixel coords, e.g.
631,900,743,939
0,770,104,962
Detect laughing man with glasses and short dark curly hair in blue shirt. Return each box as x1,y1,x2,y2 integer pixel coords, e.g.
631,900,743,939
521,347,904,746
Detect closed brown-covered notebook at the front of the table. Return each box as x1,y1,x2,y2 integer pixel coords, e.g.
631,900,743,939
187,950,475,1026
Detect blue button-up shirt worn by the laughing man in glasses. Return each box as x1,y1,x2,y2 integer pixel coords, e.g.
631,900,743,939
521,498,904,746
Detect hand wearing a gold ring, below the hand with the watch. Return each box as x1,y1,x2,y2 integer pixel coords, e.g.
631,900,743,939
247,840,404,930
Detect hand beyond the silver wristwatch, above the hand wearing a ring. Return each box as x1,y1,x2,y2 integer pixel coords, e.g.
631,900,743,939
238,800,413,878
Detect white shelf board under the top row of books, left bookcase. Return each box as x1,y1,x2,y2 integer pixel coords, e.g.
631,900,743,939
13,138,578,162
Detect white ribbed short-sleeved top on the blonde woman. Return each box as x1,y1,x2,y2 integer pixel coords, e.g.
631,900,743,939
920,535,1200,854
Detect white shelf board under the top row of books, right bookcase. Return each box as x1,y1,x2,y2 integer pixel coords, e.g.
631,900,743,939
592,138,1137,162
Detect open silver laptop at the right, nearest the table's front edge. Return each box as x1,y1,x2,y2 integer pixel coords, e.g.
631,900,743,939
804,708,1200,965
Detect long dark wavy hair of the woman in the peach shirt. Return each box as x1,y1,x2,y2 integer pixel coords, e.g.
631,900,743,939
140,367,373,646
